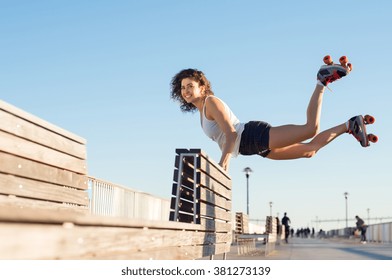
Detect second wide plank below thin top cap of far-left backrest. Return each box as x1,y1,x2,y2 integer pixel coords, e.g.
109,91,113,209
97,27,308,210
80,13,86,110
0,131,87,174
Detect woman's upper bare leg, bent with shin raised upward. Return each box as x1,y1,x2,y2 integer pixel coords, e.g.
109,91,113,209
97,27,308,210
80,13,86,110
269,85,325,149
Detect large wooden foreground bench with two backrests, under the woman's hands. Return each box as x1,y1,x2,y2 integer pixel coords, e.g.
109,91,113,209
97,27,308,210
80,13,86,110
0,101,231,260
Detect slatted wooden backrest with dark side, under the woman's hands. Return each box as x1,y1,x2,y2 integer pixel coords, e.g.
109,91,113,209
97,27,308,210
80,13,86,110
170,149,232,258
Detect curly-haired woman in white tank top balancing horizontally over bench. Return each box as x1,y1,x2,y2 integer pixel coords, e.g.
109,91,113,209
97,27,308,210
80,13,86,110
171,59,359,170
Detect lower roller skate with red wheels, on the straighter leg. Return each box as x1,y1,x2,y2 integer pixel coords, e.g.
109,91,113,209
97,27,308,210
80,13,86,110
348,115,378,147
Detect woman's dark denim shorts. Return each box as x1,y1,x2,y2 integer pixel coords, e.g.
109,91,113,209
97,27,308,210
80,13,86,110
239,121,271,157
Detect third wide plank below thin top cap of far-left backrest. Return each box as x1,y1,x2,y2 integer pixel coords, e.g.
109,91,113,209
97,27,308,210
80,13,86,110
0,152,88,190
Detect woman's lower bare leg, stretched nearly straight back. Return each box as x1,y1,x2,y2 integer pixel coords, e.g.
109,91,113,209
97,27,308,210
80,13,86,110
267,123,347,160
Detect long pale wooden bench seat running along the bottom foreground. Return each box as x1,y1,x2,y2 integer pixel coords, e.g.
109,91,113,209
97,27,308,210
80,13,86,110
0,223,231,260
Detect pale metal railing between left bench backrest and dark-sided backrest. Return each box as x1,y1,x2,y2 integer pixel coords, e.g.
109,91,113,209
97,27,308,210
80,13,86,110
88,177,170,221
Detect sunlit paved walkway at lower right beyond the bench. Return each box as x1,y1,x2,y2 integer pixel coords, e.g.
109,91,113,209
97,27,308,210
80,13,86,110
216,238,392,260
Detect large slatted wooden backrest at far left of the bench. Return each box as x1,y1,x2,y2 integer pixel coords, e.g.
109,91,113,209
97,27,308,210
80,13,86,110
0,100,88,213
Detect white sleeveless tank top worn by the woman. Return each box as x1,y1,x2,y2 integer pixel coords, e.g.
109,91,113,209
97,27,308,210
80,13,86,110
201,95,245,157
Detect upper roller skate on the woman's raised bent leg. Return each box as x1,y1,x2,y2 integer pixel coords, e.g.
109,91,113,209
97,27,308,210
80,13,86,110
317,55,352,86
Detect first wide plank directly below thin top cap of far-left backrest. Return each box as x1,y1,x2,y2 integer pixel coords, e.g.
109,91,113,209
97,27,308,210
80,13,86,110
0,110,86,159
